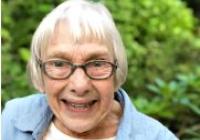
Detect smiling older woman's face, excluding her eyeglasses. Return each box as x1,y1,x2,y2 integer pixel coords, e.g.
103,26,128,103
42,22,115,134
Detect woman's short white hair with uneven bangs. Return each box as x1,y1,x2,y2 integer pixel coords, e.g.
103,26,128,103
28,0,128,90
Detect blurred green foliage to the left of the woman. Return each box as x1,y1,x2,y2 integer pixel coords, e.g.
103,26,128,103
1,0,58,106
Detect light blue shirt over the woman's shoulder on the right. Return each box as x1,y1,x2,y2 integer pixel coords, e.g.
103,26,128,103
117,90,177,140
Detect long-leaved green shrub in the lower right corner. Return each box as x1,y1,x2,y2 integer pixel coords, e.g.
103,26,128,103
140,74,200,138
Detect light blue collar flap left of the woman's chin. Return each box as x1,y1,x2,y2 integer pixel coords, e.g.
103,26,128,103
12,95,53,139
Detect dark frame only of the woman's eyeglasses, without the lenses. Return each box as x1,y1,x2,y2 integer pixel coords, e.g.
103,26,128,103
38,59,118,80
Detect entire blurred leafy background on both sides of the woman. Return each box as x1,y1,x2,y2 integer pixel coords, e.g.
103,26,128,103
1,0,200,140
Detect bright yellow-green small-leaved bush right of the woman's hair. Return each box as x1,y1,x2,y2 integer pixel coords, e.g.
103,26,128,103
105,0,200,94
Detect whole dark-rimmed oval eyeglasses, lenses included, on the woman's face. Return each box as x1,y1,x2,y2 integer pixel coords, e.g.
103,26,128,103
40,59,117,80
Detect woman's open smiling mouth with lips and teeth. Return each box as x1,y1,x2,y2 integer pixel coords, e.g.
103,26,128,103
61,99,97,112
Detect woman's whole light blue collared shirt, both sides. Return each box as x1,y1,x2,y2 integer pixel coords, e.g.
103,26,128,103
2,89,177,140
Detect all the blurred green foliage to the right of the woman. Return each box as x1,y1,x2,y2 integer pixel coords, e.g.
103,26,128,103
104,0,200,139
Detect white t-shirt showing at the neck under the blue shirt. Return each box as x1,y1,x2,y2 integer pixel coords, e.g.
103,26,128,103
43,122,116,140
